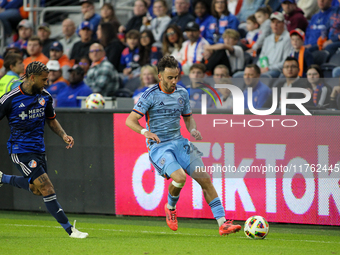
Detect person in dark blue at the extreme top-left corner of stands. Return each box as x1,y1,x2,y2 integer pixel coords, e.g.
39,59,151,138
0,0,28,38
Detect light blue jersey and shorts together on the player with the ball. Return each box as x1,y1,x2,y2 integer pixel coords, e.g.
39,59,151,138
133,84,203,178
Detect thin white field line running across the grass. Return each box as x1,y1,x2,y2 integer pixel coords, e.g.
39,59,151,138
0,224,340,244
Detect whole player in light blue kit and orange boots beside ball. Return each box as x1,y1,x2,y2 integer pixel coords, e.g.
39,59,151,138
126,56,241,235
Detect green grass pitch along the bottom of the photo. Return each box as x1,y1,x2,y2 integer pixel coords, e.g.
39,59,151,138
0,211,340,255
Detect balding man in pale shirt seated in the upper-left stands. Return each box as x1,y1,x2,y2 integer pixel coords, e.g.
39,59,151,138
59,19,80,58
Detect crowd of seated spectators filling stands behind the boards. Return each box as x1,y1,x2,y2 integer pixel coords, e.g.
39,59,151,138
0,0,340,109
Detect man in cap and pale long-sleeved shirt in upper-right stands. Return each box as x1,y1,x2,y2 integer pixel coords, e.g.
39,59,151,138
257,12,293,78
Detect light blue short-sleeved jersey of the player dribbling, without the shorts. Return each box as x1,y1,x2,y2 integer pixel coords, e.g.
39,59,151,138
133,84,191,146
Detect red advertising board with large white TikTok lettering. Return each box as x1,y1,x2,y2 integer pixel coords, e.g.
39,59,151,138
114,114,340,225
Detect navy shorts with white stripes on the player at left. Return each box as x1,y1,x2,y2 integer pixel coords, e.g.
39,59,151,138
10,153,47,183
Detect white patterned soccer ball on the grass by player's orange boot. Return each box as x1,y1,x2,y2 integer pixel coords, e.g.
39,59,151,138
244,216,269,239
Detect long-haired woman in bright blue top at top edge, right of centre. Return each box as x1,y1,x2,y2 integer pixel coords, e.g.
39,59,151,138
207,0,239,43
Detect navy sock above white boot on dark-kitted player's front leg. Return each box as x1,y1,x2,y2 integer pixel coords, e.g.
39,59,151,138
44,194,72,235
